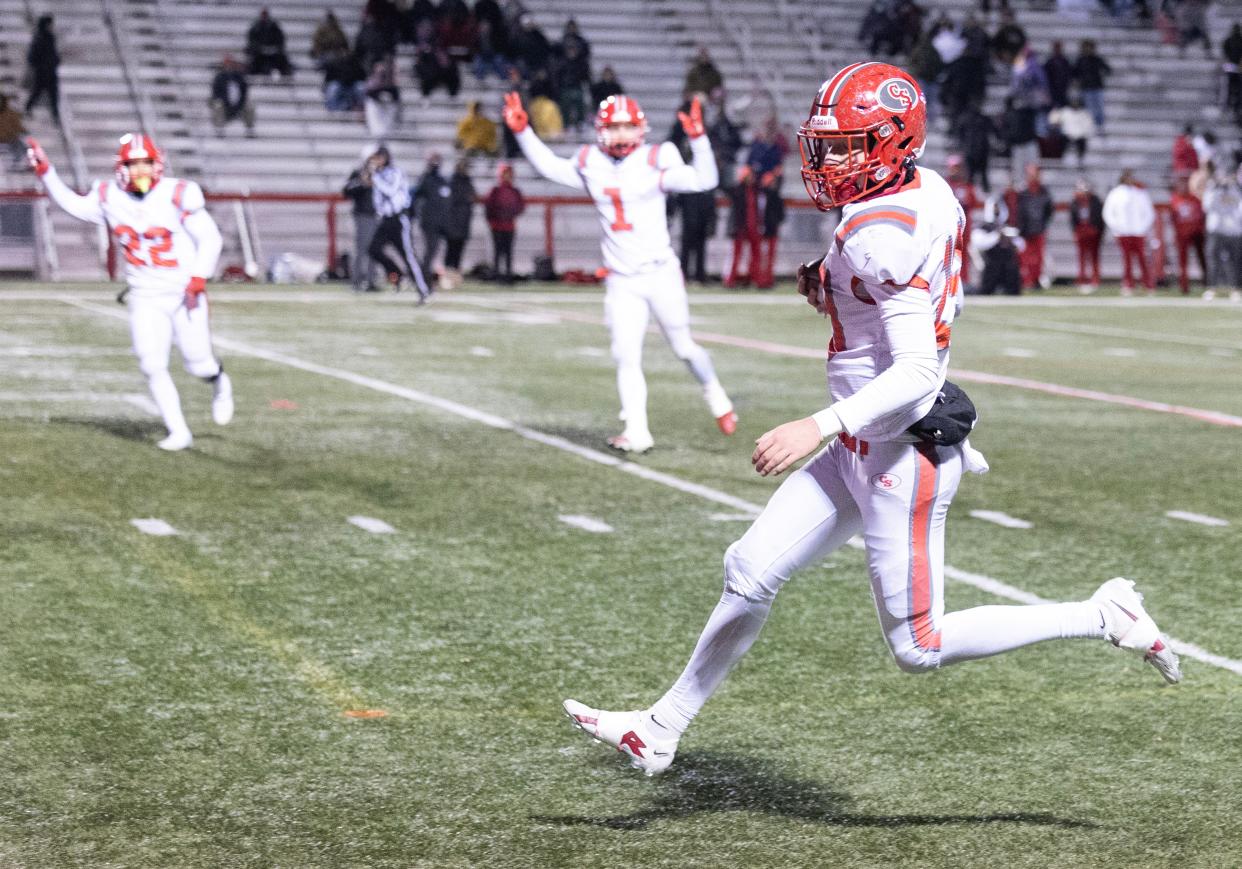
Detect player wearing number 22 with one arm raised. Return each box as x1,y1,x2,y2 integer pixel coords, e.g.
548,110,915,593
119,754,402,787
26,133,233,451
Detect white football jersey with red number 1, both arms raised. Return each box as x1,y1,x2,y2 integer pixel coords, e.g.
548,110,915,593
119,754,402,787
518,128,719,276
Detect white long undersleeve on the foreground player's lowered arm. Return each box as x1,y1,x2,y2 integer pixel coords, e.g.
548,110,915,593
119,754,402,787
816,287,940,432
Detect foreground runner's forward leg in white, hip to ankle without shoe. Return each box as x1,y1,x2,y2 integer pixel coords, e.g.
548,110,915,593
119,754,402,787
651,442,862,732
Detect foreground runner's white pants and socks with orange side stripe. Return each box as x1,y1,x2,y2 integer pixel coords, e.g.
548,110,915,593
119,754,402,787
652,439,1104,730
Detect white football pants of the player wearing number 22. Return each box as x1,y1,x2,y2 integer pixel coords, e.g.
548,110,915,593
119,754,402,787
128,293,220,433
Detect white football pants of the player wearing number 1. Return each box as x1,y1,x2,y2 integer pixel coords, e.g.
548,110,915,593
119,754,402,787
604,259,733,437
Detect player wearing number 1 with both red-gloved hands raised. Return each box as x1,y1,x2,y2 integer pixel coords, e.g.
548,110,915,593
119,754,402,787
504,93,738,453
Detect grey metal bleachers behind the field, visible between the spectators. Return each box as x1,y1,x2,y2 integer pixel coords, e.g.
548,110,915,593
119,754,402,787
0,0,1226,277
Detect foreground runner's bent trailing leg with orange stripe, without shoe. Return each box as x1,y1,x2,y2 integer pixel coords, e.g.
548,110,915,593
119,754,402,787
851,443,1104,673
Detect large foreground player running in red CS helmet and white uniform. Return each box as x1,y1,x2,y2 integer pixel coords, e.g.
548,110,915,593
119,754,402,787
564,63,1181,775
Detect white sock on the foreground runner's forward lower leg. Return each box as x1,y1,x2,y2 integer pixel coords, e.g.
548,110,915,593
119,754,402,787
648,591,771,734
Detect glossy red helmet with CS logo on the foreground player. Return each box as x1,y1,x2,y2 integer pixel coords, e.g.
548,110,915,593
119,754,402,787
797,62,927,211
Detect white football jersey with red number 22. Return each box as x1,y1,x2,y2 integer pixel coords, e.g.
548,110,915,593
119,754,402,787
43,169,221,297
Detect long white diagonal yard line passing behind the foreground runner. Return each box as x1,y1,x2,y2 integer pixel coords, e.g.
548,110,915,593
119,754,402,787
65,299,1242,675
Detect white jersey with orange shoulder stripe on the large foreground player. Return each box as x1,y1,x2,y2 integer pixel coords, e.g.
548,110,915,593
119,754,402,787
822,169,965,441
